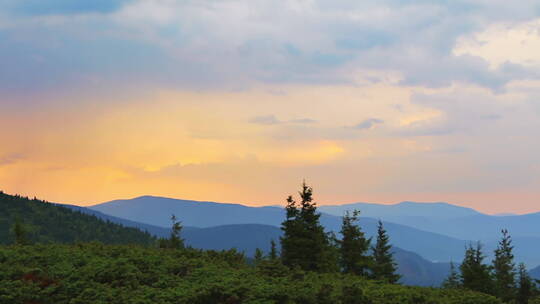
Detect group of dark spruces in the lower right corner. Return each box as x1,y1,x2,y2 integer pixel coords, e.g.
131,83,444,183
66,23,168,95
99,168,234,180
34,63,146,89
442,230,540,304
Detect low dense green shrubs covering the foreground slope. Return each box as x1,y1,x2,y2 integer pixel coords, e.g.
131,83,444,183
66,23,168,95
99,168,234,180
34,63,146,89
0,243,500,304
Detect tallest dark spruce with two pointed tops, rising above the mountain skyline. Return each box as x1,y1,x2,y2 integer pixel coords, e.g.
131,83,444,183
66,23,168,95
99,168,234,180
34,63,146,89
281,182,337,271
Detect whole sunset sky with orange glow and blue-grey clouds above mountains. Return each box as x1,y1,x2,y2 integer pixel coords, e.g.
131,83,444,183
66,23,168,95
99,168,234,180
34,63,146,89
0,0,540,214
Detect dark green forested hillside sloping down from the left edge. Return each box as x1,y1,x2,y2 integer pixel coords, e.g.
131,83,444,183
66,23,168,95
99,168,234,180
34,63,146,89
0,192,155,245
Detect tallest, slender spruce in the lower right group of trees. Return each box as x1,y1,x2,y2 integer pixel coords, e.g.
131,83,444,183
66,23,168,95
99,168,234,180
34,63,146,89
493,229,516,302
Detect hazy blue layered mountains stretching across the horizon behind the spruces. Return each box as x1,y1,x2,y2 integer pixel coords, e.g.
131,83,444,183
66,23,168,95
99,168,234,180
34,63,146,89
90,196,540,267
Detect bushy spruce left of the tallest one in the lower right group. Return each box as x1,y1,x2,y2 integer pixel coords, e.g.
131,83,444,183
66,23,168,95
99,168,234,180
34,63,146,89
459,242,493,294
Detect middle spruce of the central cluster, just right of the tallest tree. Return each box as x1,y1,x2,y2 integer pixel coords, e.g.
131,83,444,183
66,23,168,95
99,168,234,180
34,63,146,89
338,210,372,276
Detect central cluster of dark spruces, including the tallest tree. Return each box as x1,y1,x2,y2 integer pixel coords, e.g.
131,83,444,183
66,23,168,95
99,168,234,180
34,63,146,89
272,183,400,283
